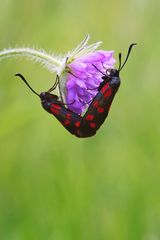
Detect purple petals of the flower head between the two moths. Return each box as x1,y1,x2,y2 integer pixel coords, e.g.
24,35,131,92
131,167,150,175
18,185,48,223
65,50,116,114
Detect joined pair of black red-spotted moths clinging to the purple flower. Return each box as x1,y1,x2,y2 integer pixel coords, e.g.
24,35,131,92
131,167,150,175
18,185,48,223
16,43,136,138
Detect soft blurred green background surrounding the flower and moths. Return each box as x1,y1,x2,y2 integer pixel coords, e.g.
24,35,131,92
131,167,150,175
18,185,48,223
0,0,160,240
